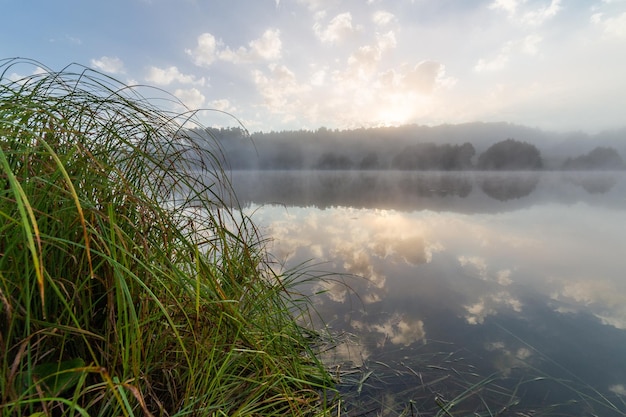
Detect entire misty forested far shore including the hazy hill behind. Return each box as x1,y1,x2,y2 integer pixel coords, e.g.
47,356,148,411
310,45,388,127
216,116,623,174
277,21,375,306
194,123,626,171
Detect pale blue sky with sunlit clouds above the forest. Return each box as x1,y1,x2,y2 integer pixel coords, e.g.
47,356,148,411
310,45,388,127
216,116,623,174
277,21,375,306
0,0,626,133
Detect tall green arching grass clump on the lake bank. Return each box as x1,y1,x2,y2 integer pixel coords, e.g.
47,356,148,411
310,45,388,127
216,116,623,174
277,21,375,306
0,59,331,417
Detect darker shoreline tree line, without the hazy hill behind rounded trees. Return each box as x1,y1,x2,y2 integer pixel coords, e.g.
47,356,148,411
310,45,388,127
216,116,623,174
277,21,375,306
193,124,626,171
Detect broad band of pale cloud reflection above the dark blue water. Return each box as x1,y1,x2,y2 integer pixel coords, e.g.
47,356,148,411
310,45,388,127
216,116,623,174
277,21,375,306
251,191,626,328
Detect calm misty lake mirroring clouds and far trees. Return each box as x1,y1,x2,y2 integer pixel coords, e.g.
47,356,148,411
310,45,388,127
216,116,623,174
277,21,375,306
231,171,626,416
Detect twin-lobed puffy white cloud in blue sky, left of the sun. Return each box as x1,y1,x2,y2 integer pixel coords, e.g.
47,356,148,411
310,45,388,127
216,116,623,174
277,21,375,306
185,29,282,67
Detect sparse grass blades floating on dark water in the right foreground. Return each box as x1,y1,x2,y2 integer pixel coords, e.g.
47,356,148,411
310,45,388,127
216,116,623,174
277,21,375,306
326,334,626,417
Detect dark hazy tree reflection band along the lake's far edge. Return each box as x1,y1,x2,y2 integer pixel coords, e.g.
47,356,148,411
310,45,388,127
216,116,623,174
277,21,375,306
228,170,626,212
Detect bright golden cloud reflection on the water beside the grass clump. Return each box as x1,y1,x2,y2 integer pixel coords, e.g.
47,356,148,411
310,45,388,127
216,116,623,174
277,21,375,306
255,207,443,303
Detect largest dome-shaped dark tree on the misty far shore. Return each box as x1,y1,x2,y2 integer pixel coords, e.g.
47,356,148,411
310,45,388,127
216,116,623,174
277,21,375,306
478,138,543,171
